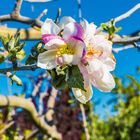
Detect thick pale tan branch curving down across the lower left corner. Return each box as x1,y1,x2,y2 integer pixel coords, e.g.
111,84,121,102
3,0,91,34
0,95,62,139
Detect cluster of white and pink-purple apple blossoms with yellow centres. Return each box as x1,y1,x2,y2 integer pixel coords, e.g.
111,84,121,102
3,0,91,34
37,17,116,103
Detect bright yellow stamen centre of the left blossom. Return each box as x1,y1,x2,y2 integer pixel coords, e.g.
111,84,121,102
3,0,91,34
57,44,74,56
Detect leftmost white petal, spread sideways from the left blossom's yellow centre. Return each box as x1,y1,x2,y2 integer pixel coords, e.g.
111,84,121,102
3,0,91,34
37,50,57,70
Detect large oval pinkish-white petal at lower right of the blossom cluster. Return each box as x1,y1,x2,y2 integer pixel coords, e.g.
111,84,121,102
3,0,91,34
88,59,115,92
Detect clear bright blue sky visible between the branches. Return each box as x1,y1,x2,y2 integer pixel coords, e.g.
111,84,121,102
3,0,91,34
0,0,140,118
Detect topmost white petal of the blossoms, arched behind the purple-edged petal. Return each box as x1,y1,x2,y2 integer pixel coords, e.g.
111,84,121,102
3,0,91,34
59,16,75,29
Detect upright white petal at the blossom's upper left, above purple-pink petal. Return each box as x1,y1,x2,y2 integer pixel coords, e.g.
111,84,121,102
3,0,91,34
41,19,60,35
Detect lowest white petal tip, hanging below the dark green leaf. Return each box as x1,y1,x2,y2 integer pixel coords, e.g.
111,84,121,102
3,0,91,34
72,85,93,104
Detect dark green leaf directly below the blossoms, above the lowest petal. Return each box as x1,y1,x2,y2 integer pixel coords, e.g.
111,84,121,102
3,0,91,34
66,65,85,91
